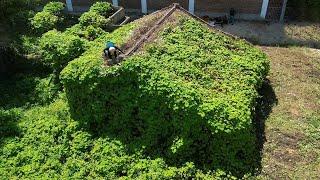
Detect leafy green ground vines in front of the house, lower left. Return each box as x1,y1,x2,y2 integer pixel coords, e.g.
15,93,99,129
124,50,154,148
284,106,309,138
0,98,232,180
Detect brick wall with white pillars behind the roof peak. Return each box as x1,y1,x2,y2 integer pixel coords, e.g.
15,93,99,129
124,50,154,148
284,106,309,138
66,0,286,20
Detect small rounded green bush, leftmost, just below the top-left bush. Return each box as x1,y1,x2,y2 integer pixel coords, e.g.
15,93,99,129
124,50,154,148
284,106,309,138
31,11,59,33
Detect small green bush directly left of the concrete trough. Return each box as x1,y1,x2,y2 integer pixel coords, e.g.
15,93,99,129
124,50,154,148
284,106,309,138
79,11,110,28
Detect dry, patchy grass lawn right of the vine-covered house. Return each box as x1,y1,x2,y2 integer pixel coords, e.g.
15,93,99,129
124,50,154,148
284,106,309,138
258,47,320,179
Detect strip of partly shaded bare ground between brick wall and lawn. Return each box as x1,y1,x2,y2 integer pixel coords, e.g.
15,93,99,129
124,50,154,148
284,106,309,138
217,21,320,49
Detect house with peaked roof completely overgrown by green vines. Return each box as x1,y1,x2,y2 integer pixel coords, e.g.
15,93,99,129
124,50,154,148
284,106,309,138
60,5,269,176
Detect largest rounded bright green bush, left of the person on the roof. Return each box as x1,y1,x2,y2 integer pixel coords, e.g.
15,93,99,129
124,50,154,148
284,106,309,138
39,30,85,72
